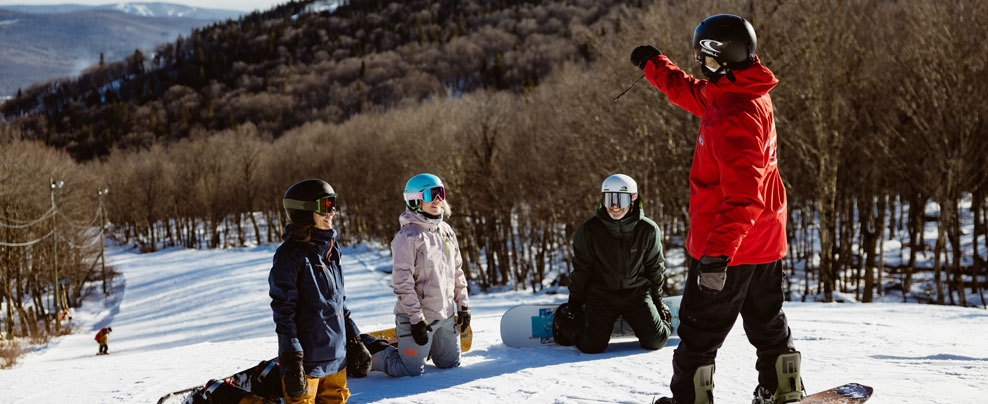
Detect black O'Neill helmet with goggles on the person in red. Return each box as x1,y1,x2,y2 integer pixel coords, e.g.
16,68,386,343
693,14,758,78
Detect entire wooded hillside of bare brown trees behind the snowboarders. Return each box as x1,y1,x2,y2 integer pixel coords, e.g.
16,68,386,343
0,0,988,348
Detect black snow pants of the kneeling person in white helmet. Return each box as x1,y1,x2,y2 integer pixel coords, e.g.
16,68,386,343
572,288,672,353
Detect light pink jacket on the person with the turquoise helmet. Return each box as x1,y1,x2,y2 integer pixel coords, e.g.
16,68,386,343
391,210,470,324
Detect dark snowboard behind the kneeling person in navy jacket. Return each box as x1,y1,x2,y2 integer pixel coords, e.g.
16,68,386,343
158,358,283,404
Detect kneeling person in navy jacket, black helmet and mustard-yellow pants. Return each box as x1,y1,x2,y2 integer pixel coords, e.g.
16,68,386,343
268,179,370,404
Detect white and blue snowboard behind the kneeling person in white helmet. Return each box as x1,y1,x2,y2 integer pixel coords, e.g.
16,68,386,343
501,296,682,348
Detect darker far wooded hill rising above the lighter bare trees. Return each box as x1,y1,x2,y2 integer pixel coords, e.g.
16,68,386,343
2,0,640,160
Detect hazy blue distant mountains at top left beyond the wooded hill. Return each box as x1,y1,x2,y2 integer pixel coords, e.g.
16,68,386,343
0,3,240,96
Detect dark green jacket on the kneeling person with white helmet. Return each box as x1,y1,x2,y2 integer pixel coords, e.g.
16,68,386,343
569,198,666,304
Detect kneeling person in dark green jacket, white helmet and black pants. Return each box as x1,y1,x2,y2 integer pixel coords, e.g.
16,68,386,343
552,174,672,353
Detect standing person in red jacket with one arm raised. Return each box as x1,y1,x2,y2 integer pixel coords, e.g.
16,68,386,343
631,14,804,404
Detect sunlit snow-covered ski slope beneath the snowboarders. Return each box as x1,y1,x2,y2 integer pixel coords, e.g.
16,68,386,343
0,241,988,404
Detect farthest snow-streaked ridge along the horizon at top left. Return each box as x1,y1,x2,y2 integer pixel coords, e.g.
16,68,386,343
0,2,243,21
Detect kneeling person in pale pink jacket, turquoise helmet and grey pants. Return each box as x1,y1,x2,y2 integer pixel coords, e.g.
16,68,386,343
373,174,470,377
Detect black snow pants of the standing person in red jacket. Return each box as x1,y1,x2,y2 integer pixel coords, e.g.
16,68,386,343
669,258,796,404
